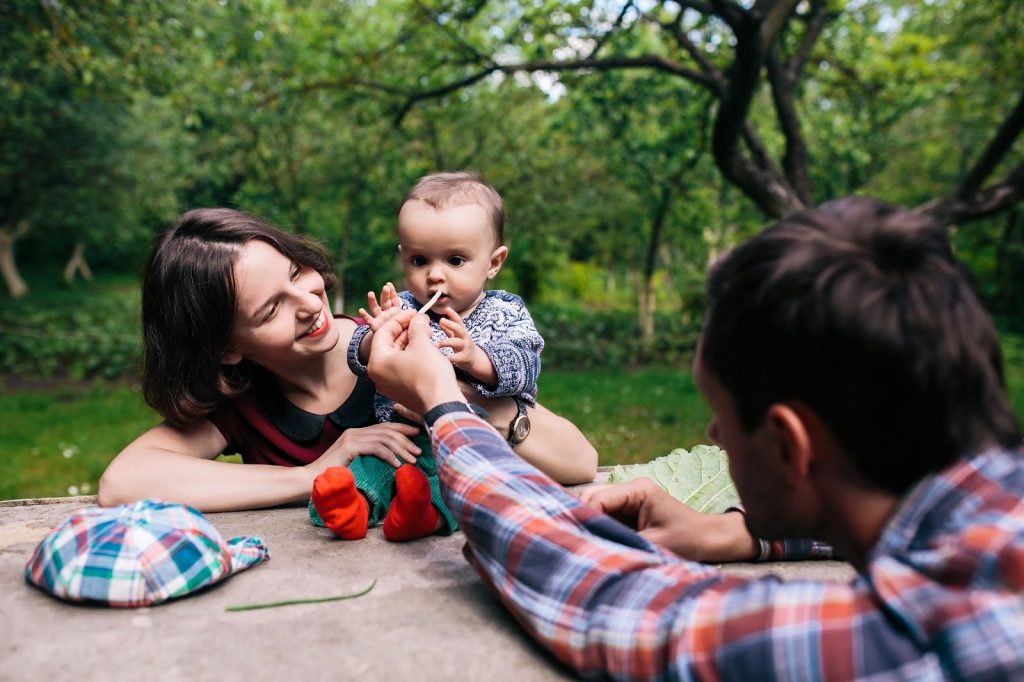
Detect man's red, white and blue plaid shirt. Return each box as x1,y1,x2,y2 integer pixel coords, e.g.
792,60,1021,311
434,413,1024,680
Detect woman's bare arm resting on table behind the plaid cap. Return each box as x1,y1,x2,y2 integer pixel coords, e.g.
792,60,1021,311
99,420,311,512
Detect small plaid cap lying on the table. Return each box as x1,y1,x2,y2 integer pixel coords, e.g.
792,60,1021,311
25,500,269,606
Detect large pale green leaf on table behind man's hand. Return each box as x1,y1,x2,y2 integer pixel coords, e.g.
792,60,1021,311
608,445,739,514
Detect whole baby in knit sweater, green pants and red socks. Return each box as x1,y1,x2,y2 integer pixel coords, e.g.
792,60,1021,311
310,172,597,540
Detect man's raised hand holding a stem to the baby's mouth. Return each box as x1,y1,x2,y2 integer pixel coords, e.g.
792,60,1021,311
367,310,465,415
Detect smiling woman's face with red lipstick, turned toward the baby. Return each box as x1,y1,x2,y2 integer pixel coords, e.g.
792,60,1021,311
223,240,339,372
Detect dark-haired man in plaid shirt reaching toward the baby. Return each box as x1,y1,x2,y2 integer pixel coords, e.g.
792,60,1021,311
370,199,1024,680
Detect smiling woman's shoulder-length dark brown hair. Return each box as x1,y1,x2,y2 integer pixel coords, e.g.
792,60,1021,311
142,209,335,426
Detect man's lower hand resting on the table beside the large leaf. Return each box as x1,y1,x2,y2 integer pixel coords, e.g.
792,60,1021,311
580,478,759,562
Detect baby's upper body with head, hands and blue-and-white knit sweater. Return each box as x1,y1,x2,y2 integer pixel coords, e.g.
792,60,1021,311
348,172,544,430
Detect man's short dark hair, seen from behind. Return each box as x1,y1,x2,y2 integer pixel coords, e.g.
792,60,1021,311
700,193,1021,494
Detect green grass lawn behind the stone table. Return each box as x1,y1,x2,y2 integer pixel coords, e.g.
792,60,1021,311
0,335,1024,499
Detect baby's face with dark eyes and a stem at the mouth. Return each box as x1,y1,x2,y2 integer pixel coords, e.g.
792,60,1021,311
398,196,507,315
